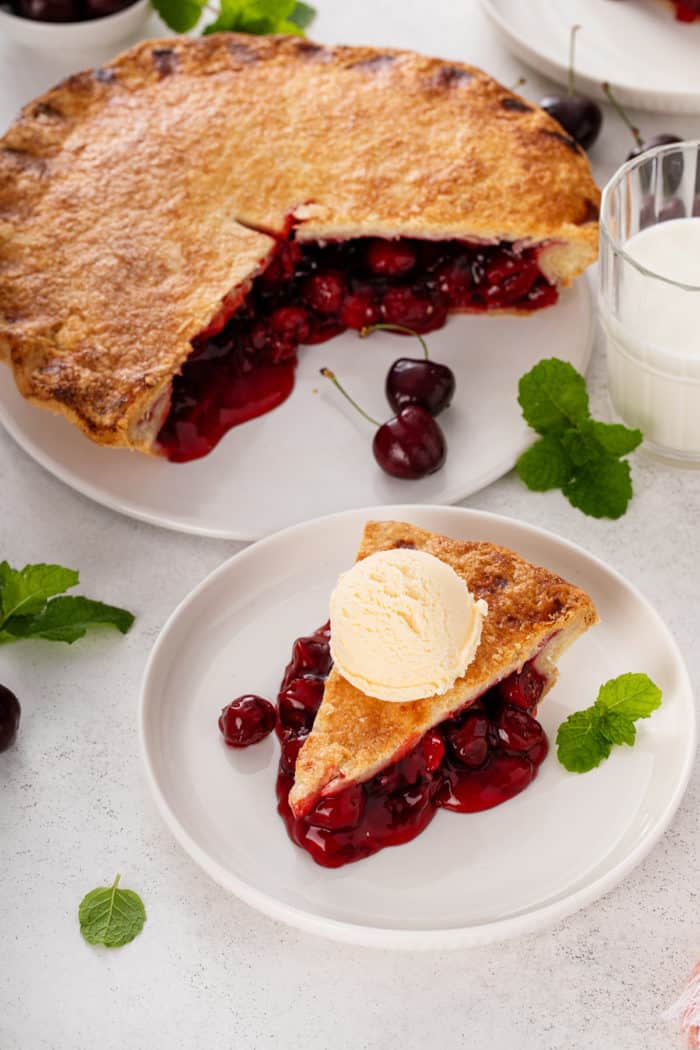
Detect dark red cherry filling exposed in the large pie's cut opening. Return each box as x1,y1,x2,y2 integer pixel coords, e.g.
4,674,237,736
157,237,557,462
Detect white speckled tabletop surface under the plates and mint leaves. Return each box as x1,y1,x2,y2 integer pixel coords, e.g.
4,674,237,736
0,6,700,1050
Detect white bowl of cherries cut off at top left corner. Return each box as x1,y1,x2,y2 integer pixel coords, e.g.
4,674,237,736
0,0,152,54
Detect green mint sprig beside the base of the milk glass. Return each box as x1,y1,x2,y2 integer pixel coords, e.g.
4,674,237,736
515,357,642,519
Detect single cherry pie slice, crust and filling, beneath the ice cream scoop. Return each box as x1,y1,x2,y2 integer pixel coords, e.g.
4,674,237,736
277,522,597,867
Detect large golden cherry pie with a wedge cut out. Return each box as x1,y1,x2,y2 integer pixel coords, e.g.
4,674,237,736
0,34,599,461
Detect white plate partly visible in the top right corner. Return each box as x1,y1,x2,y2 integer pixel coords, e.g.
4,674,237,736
482,0,700,113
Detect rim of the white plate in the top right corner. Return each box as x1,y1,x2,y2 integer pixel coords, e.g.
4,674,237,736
481,0,700,114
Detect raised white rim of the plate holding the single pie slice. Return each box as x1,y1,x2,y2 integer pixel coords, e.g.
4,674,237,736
139,503,697,950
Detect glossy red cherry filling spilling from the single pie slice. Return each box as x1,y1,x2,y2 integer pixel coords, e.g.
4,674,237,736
277,624,548,867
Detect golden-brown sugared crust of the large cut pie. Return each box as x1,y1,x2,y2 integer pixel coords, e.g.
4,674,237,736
0,34,599,452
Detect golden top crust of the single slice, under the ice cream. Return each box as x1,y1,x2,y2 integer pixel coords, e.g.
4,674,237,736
290,522,598,817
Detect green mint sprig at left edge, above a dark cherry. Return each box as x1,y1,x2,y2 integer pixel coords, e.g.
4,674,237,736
0,562,133,645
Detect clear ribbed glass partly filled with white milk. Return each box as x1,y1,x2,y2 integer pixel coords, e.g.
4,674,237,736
600,141,700,466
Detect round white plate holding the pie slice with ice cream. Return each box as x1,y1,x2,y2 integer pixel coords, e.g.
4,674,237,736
141,505,695,949
